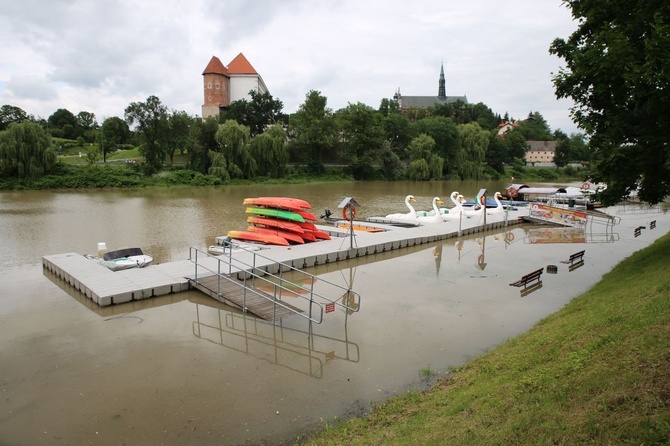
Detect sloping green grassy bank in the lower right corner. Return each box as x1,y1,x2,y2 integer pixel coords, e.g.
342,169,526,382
301,234,670,445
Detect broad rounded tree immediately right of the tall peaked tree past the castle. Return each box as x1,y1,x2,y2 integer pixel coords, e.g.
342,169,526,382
336,102,384,180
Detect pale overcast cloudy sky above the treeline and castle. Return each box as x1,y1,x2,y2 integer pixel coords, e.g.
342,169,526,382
0,0,577,133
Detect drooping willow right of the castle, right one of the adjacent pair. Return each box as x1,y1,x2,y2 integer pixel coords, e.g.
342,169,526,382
251,125,288,178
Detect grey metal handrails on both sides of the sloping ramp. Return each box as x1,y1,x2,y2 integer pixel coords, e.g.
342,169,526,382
189,247,360,324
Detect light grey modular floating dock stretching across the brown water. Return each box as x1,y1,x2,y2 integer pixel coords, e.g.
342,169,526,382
42,212,523,312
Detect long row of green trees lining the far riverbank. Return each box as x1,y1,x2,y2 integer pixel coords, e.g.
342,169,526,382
0,91,590,186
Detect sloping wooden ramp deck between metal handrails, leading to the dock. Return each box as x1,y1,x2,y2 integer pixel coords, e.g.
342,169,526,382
188,274,302,321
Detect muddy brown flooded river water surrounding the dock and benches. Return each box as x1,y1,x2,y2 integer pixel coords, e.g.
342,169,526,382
0,182,670,445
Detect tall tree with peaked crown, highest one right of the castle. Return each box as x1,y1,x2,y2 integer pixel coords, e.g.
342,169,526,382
289,90,336,175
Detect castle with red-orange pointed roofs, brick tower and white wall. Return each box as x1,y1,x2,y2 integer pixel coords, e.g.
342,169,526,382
202,53,268,119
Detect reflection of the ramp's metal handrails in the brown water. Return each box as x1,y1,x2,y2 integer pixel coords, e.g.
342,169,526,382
193,303,360,379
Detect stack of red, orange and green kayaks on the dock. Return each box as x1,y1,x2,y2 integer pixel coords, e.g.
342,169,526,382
228,197,330,246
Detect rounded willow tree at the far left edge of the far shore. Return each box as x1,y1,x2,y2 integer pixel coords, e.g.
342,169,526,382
0,121,57,180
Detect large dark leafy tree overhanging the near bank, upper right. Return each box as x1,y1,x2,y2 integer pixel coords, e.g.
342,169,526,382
549,0,670,204
